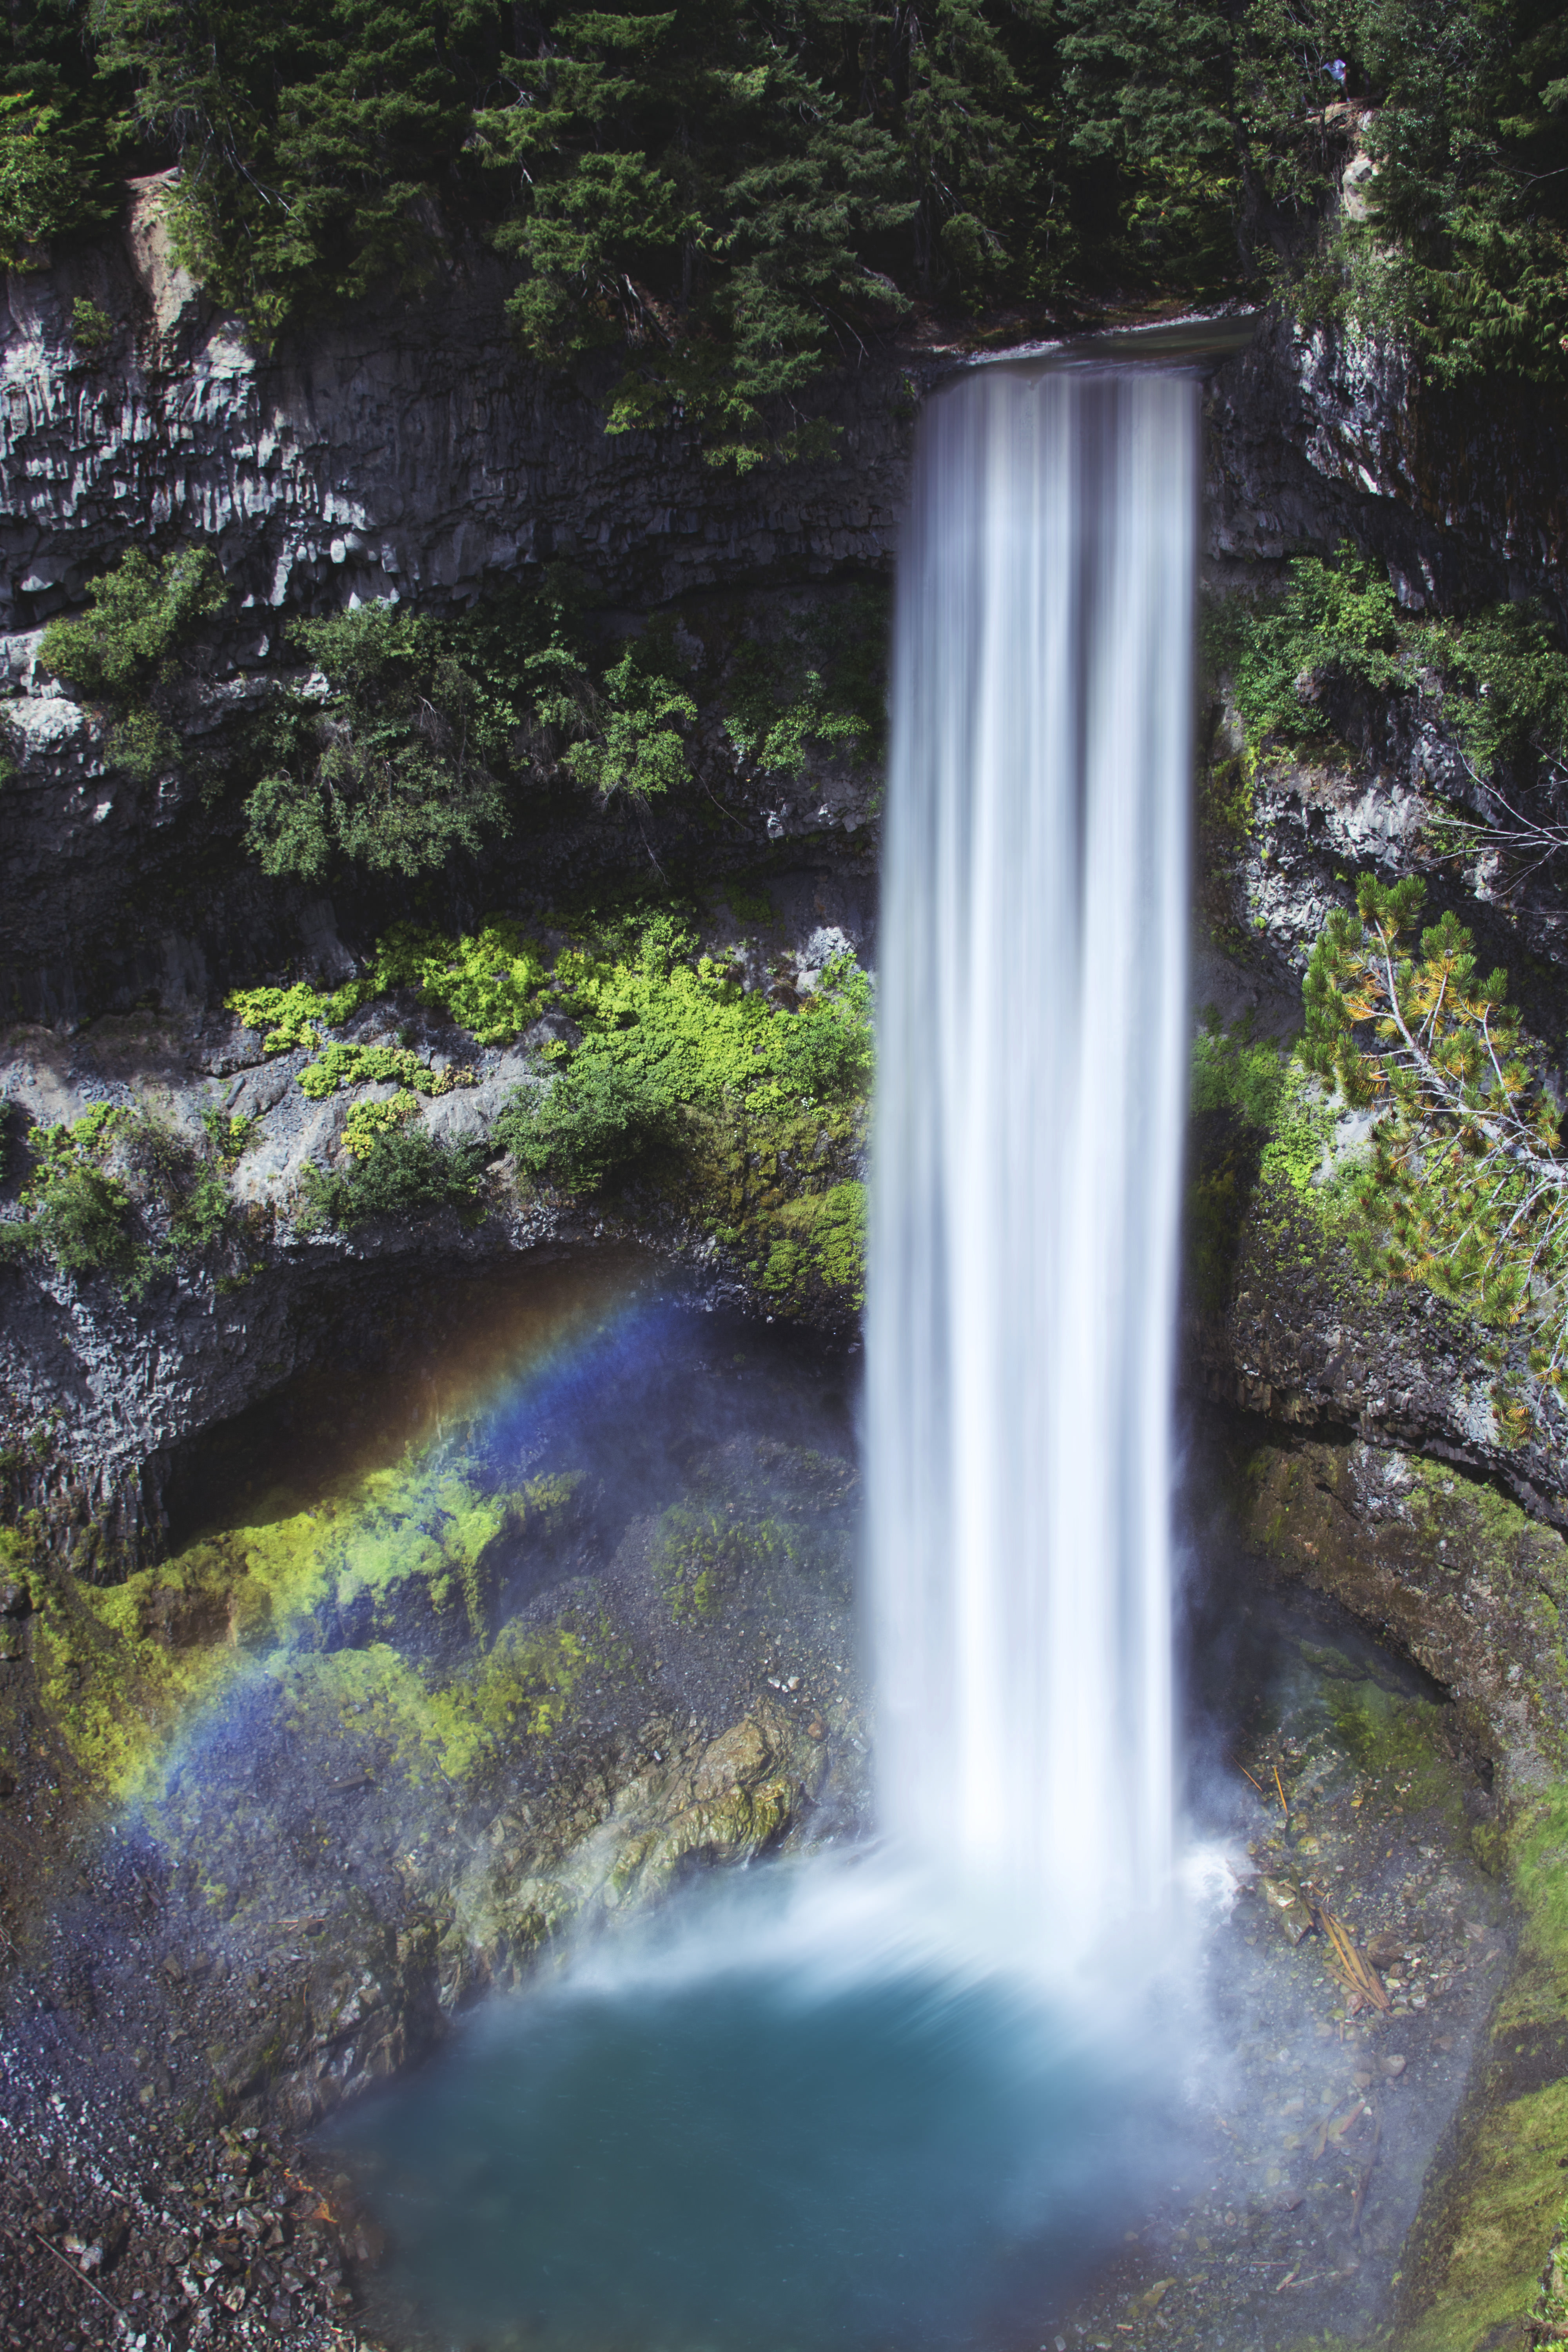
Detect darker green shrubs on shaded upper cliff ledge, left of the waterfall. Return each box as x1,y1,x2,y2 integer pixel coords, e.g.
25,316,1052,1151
231,579,884,884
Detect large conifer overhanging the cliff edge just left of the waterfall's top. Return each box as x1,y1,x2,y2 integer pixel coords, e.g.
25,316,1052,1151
477,0,915,466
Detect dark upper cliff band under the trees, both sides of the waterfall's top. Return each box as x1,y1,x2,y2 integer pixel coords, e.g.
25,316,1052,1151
0,205,1568,661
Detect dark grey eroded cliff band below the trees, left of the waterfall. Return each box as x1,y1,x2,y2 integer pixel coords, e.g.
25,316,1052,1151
0,226,907,640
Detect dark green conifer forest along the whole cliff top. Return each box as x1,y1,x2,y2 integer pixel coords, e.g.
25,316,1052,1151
0,0,1568,419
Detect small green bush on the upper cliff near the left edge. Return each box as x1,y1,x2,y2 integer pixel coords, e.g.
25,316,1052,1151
38,548,228,783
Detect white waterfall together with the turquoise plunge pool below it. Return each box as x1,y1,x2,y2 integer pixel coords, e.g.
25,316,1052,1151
315,369,1196,2352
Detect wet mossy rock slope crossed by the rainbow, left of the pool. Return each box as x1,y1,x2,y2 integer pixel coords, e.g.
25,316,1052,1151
0,1277,865,2352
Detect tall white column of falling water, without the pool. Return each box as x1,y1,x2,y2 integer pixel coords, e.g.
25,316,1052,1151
867,367,1196,1966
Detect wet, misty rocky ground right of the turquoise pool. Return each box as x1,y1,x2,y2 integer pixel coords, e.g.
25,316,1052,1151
1034,1555,1519,2352
